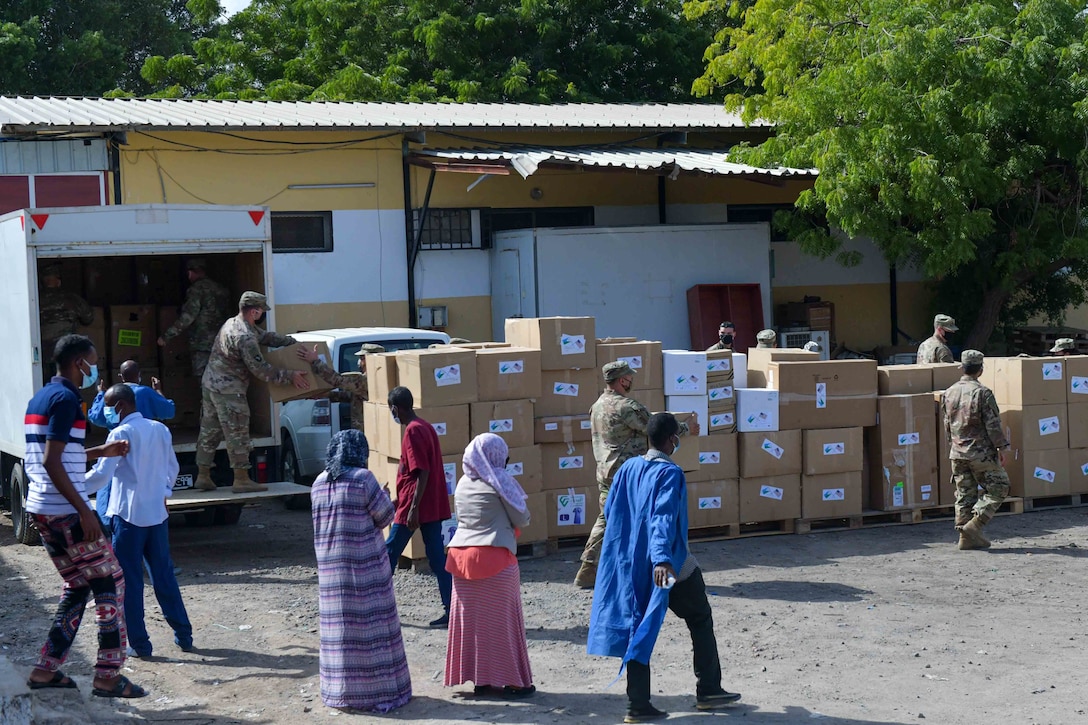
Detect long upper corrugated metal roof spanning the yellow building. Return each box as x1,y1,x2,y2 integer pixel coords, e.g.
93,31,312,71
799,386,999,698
0,97,769,133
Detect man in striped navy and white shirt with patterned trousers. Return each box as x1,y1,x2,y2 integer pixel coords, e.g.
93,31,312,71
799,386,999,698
25,335,147,698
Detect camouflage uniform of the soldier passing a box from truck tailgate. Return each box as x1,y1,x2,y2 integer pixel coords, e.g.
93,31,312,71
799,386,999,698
197,314,295,470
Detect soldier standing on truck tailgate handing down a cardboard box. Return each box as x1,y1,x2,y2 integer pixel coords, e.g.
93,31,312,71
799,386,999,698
196,292,310,493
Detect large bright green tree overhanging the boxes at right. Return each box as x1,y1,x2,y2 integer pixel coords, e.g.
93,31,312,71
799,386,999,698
685,0,1088,347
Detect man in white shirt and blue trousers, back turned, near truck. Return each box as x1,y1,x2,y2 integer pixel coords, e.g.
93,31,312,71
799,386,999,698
86,384,193,658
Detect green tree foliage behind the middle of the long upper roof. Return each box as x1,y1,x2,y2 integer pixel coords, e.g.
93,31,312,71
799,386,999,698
144,0,720,102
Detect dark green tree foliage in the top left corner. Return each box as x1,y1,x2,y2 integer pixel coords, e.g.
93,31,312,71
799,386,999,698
0,0,207,96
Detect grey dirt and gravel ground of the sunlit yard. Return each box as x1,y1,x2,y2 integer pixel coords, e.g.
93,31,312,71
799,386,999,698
0,502,1088,725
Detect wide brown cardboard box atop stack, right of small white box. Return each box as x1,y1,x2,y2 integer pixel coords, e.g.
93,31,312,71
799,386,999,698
767,360,879,430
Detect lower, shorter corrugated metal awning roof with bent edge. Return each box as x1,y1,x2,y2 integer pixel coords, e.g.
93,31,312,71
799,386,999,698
412,147,818,179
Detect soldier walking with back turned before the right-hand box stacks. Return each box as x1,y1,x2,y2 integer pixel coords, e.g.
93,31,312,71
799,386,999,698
944,349,1009,549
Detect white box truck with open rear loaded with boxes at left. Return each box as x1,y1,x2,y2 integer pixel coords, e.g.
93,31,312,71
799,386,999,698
0,205,306,543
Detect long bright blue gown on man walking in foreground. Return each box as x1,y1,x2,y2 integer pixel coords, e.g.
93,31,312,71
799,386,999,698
585,456,688,668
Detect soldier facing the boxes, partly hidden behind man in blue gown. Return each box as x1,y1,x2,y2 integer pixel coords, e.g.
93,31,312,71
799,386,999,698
574,360,698,589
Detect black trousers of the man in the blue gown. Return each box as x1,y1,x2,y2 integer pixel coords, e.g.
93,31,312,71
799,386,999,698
627,568,721,710
